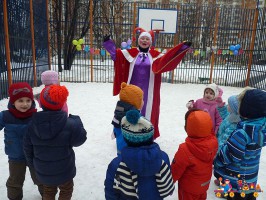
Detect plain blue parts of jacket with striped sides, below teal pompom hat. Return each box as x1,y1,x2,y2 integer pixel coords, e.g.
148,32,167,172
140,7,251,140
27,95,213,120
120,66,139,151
104,143,172,200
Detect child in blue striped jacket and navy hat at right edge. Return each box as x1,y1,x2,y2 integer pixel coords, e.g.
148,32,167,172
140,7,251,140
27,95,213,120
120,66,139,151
214,89,266,200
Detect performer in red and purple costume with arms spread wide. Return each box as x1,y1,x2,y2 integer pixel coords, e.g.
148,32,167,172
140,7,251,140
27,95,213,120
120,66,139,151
103,28,191,139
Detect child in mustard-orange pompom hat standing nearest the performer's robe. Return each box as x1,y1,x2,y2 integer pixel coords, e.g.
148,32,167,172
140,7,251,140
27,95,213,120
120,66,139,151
112,82,143,155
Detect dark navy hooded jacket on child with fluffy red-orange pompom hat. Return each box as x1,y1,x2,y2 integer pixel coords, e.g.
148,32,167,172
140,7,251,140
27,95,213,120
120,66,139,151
24,111,87,186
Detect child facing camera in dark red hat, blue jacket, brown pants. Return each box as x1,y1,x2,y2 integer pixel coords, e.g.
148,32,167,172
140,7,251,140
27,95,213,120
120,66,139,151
0,82,42,200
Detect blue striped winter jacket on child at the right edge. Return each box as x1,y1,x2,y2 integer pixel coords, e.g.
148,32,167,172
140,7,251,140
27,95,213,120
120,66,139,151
214,117,266,189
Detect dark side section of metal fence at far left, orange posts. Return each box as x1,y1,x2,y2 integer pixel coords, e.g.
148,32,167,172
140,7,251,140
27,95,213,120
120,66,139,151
0,0,49,99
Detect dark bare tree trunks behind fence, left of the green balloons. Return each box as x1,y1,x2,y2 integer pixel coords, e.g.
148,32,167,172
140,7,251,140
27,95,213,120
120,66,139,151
50,0,97,71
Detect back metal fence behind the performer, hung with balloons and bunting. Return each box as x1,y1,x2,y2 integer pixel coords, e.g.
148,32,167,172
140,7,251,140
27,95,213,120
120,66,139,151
50,1,266,89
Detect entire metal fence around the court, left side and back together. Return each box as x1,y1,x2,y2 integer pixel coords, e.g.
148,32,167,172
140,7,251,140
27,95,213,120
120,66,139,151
0,0,266,99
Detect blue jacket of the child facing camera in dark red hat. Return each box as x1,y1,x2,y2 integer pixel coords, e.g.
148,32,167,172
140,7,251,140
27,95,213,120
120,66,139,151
0,110,31,162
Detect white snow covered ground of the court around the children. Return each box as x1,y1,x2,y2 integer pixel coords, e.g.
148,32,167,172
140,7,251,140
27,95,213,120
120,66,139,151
0,82,266,200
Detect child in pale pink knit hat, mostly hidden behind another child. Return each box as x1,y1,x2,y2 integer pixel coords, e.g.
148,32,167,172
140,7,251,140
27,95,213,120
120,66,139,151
34,70,68,113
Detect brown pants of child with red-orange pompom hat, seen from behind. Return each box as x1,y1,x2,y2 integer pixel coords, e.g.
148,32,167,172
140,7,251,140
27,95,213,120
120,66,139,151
43,179,74,200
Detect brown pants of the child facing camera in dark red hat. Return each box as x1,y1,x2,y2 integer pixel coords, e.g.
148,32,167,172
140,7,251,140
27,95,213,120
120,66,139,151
6,161,42,200
